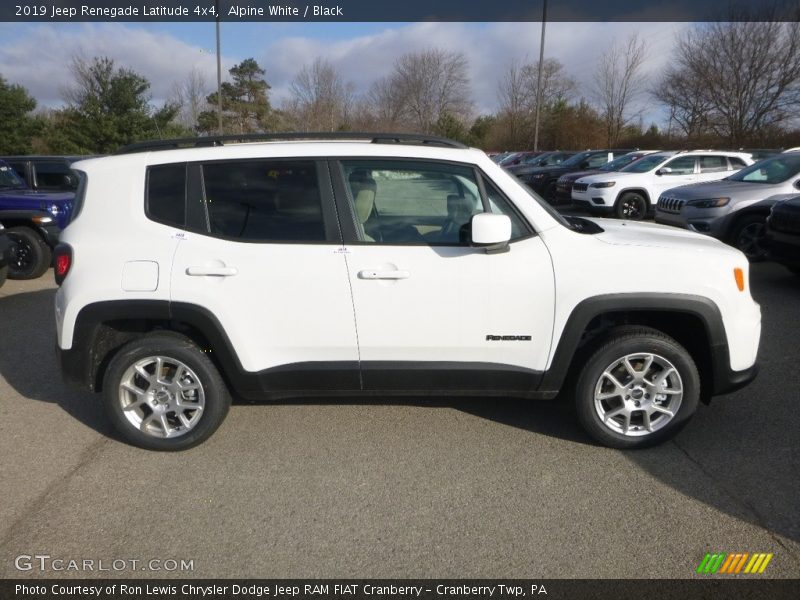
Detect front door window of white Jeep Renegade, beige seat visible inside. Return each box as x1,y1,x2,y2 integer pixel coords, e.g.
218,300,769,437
342,160,527,246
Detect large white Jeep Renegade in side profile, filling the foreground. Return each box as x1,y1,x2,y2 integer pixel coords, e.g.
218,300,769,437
55,134,761,450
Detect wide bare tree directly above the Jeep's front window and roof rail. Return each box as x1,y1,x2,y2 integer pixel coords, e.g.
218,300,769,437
380,48,472,133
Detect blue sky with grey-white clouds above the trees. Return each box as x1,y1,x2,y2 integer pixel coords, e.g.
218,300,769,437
0,22,690,126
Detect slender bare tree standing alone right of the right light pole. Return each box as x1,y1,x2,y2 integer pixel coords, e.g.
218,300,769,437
594,34,646,146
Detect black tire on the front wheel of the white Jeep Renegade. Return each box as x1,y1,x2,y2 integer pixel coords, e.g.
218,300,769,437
575,327,700,449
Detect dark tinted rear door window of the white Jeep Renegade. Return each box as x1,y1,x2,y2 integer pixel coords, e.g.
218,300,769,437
203,160,325,242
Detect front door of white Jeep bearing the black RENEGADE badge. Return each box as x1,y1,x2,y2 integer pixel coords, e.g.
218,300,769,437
331,159,554,392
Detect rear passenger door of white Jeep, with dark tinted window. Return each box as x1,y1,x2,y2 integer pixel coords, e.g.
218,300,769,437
171,158,360,392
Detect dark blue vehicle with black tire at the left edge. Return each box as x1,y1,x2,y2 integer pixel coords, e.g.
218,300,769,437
0,160,75,279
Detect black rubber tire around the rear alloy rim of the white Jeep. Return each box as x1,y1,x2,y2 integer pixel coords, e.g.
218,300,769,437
103,332,231,451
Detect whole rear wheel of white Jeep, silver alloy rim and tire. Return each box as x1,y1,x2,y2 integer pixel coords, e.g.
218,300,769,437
103,333,231,450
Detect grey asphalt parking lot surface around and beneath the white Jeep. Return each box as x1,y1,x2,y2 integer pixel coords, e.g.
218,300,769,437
0,264,800,578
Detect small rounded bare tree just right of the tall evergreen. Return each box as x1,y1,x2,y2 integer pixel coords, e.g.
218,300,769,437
287,58,353,131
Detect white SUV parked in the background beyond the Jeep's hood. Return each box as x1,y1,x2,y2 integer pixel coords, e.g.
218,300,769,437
572,150,753,220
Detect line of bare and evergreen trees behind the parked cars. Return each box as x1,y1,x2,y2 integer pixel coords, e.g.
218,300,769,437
0,14,800,154
